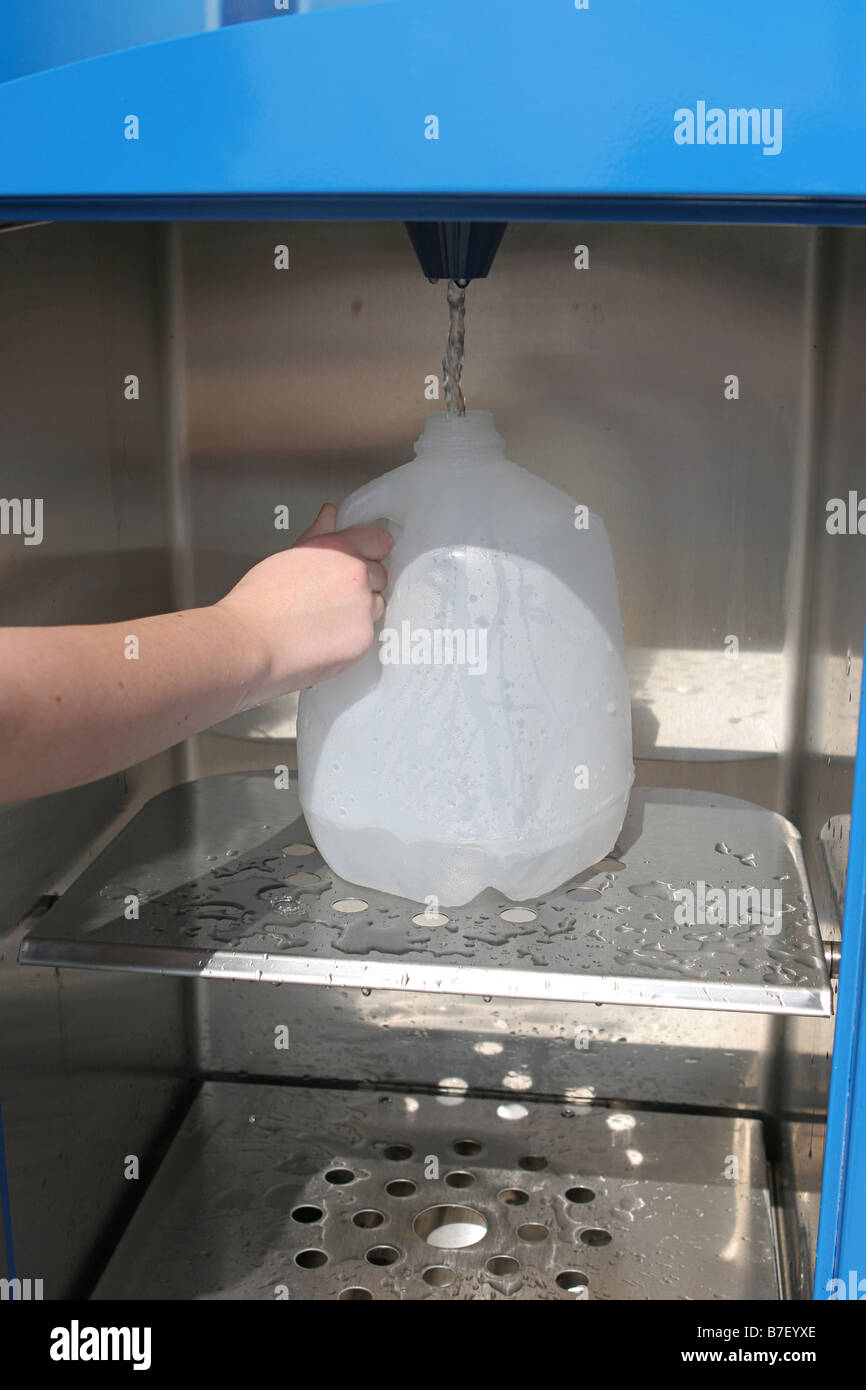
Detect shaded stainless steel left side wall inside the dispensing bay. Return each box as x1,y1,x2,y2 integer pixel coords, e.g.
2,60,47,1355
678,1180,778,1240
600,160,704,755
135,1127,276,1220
0,224,188,1298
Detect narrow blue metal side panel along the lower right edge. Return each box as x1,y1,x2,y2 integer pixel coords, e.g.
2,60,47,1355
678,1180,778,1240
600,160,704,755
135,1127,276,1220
815,625,866,1298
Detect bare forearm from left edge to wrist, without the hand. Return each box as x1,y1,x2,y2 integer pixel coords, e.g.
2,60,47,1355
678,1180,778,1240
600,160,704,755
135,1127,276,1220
0,606,267,802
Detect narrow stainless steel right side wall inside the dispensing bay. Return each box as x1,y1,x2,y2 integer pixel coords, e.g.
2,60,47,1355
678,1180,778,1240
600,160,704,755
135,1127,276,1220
780,229,866,1297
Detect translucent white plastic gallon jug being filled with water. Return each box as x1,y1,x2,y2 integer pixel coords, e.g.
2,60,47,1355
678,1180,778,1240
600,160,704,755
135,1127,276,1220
297,410,634,909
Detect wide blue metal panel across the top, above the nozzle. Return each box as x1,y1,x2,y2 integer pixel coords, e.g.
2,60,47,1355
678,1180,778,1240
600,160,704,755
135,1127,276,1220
0,0,866,215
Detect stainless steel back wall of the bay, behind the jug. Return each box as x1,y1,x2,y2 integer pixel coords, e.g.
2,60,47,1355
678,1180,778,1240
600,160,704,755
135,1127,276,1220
182,224,866,1295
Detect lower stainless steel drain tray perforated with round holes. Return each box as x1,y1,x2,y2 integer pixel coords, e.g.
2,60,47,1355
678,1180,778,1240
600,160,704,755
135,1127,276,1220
93,1083,778,1301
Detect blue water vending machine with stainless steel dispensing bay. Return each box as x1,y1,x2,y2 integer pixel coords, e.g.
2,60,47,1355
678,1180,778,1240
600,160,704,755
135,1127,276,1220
0,0,866,1302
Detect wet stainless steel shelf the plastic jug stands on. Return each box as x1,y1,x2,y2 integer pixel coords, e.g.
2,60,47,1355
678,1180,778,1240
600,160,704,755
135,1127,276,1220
19,773,830,1015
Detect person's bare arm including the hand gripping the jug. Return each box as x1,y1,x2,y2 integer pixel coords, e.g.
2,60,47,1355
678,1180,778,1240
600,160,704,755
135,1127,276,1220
0,505,392,802
